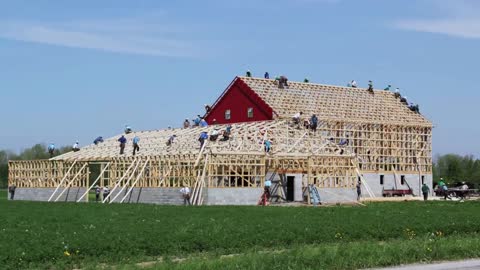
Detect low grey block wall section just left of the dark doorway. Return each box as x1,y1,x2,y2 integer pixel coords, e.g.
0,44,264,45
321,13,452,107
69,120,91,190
204,188,263,205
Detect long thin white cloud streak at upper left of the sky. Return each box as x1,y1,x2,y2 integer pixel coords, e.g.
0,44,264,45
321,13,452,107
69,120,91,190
0,21,194,57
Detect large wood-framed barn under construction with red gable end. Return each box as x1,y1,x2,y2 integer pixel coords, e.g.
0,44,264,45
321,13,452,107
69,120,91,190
9,77,432,205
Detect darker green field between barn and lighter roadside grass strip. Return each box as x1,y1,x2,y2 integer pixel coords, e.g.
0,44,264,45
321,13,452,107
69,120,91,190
0,201,480,269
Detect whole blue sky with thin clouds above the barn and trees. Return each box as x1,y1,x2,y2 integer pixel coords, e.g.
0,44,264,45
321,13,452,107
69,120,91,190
0,0,480,156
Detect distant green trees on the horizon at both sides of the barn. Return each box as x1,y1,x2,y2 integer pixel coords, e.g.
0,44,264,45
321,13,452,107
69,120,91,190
0,144,480,188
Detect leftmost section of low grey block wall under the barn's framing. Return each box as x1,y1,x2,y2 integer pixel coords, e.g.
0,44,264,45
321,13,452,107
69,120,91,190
8,188,87,202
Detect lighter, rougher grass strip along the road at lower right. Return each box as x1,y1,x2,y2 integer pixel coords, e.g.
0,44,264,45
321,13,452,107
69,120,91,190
143,235,480,269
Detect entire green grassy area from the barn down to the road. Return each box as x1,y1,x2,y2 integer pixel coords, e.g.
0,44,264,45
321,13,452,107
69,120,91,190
0,197,480,269
